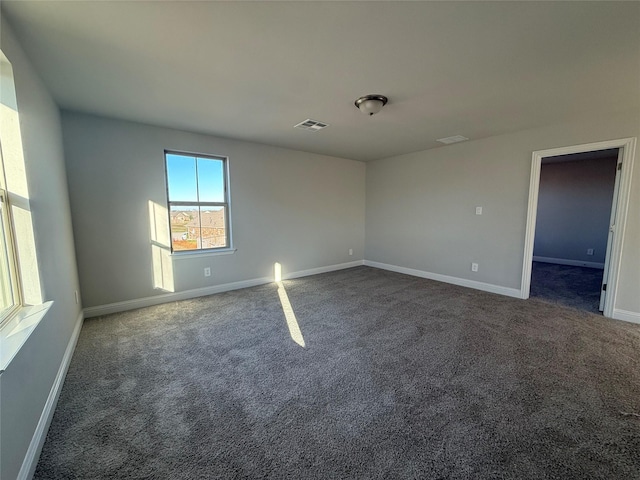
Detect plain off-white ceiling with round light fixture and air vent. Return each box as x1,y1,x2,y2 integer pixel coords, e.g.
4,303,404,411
2,0,640,160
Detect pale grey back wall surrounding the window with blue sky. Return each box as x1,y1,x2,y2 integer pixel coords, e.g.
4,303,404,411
62,112,365,307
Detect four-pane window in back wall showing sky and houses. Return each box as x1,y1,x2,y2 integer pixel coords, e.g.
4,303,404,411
165,152,231,252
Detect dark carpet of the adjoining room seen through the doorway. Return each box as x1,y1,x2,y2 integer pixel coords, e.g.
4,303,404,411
530,262,603,314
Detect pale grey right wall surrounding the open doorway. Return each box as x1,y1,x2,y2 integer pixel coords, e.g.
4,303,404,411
365,111,640,315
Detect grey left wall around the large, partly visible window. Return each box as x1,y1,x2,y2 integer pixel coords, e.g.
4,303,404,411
0,18,81,479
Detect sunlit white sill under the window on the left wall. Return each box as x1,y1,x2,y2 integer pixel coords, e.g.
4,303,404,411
0,301,53,373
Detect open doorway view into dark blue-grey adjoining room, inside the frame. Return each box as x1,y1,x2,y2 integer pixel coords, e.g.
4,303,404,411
530,148,619,314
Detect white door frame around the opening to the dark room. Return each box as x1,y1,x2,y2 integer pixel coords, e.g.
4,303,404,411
521,138,636,317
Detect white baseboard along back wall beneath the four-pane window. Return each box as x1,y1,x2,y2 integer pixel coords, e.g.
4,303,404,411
84,260,363,318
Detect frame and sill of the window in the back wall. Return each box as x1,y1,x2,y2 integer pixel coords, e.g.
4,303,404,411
164,150,234,255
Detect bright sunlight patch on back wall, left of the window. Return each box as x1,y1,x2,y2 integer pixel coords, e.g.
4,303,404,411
149,200,175,292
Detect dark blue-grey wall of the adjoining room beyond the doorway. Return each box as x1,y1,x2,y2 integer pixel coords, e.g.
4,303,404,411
533,157,617,267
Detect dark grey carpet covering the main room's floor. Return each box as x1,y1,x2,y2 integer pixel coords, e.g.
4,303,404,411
35,267,640,479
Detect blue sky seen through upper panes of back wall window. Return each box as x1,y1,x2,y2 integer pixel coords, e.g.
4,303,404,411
167,153,224,202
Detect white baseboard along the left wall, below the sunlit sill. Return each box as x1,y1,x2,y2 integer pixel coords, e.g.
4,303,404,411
17,312,84,480
